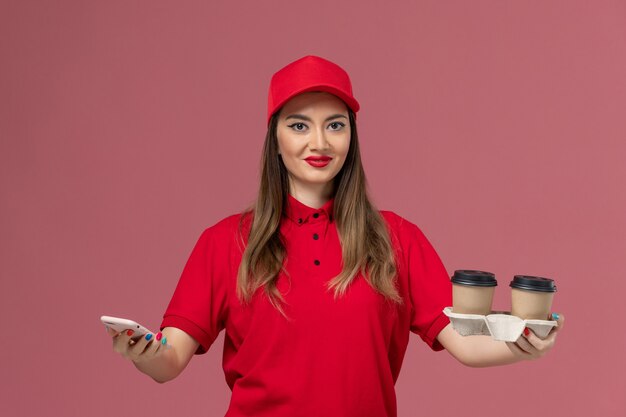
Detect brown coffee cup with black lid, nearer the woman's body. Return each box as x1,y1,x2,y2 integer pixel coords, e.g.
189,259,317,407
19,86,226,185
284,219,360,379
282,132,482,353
451,270,498,315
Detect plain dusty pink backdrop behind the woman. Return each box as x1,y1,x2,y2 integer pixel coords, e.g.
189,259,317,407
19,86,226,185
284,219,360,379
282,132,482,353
0,0,626,417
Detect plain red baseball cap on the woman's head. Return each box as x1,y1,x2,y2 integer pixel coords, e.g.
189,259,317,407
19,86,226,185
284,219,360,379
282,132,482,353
267,55,360,125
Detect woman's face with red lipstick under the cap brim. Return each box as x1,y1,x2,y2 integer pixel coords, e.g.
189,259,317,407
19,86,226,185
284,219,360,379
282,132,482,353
276,92,350,196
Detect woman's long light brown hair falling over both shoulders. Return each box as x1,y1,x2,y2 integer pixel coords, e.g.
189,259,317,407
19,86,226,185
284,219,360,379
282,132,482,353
237,108,402,315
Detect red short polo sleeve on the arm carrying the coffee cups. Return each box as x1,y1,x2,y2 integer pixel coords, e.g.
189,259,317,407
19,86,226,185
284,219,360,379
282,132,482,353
401,214,452,351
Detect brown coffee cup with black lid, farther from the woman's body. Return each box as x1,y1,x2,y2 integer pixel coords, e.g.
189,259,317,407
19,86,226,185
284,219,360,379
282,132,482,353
510,275,556,320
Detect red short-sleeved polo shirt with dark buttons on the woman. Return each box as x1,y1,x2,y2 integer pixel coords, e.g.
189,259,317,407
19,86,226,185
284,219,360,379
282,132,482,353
161,195,452,417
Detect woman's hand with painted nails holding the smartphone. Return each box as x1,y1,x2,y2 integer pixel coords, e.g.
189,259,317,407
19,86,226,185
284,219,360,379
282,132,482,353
107,328,167,363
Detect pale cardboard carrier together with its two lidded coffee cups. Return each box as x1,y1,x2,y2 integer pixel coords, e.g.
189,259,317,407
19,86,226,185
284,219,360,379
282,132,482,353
443,270,556,342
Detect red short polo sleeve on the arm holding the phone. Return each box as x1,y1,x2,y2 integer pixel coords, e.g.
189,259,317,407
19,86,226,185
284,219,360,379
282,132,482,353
160,221,230,354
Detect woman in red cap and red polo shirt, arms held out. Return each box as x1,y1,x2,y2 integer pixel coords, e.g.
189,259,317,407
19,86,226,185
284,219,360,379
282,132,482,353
111,56,563,417
